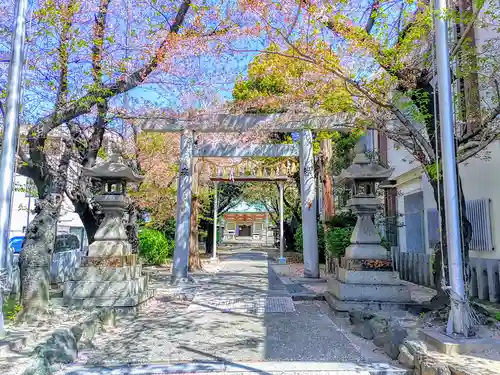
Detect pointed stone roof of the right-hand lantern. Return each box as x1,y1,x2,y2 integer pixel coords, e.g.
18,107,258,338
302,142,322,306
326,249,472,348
335,140,394,183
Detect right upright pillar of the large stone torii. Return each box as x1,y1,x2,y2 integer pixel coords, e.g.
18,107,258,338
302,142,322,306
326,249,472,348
299,130,319,279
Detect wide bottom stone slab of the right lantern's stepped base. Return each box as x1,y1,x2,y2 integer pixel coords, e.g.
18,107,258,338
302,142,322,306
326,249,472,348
328,279,411,303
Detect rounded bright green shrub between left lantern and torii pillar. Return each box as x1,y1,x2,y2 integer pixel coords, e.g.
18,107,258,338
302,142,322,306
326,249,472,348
139,229,174,266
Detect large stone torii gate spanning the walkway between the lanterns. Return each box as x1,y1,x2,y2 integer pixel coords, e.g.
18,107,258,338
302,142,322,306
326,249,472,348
139,114,350,284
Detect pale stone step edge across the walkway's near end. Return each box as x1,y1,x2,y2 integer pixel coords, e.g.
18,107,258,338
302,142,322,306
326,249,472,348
57,361,413,375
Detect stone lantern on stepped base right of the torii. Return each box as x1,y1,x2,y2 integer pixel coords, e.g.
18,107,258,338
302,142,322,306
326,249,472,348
327,138,410,311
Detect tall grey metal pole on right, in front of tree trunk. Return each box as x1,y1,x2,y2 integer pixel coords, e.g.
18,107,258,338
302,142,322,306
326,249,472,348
435,0,470,335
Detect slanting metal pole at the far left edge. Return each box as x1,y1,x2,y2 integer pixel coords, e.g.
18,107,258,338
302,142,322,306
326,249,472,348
0,0,28,336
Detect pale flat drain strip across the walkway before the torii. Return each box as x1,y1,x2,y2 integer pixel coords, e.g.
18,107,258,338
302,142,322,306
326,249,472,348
187,296,295,315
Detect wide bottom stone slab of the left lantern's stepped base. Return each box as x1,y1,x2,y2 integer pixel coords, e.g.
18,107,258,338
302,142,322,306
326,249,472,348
63,276,148,299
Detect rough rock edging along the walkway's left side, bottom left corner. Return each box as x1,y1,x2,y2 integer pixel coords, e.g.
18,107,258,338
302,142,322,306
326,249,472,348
22,308,116,375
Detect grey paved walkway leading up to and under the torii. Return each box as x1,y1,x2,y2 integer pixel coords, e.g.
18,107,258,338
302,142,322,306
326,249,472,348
54,251,408,375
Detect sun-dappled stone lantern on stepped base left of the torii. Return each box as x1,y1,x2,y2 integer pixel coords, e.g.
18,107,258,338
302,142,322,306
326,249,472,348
63,155,153,308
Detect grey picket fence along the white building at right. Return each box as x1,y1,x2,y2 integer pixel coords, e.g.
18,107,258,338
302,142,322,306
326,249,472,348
391,247,500,302
